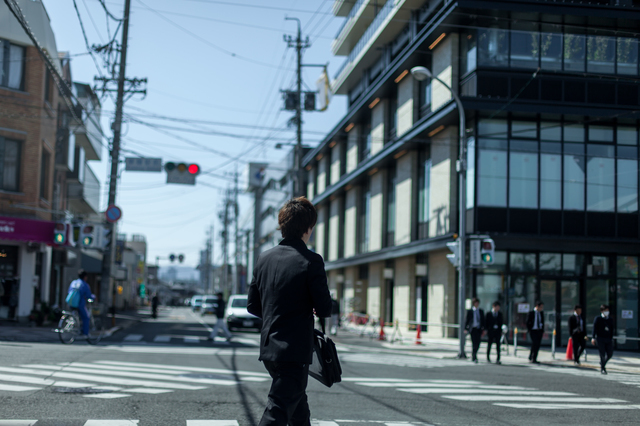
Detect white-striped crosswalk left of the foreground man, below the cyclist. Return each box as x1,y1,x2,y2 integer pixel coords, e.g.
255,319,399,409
0,361,270,400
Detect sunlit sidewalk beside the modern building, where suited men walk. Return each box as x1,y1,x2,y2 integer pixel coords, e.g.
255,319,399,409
340,324,640,374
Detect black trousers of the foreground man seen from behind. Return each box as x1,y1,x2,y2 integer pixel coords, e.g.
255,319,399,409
259,361,311,426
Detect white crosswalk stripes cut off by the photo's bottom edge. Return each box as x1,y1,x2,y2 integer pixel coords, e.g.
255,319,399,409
0,419,433,426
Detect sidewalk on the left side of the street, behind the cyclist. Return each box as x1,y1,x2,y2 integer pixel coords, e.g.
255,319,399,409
0,308,151,343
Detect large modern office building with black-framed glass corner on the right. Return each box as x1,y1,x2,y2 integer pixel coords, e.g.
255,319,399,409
303,0,640,350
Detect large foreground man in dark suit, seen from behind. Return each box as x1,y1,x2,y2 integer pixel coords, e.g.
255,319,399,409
247,197,331,426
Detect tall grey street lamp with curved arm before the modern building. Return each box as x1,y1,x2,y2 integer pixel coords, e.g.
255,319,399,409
411,67,467,358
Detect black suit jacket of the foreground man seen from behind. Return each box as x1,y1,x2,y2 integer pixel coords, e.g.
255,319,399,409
247,239,331,364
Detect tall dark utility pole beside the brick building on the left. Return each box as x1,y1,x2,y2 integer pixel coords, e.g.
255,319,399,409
100,0,131,326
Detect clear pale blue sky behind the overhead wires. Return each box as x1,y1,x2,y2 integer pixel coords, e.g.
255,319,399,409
42,0,346,267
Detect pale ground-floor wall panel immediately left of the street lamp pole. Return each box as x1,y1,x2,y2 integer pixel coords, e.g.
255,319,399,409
427,250,458,337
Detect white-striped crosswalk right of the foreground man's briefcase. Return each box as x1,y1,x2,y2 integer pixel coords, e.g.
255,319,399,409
342,380,640,410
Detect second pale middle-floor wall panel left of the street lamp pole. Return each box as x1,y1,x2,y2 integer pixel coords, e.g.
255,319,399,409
395,151,417,246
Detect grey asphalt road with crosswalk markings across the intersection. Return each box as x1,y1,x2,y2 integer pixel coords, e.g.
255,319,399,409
0,308,640,426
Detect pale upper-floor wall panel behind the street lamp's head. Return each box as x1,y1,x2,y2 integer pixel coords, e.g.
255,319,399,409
431,33,458,111
